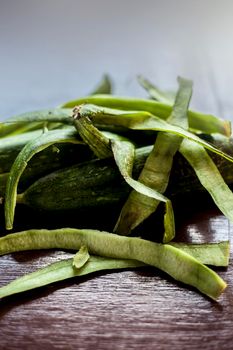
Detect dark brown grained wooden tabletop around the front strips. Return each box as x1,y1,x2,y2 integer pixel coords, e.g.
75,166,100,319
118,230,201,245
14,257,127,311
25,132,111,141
0,203,233,349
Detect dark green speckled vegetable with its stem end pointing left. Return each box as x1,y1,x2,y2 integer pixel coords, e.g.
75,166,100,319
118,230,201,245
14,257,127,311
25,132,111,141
21,159,128,211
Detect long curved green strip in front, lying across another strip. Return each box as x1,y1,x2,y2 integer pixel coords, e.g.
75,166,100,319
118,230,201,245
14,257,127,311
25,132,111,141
0,228,226,299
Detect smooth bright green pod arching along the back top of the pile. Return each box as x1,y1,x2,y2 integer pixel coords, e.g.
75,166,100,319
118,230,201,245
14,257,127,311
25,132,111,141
61,95,231,136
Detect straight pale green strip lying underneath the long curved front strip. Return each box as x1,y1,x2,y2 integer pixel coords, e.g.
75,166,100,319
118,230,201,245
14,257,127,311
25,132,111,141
0,241,230,298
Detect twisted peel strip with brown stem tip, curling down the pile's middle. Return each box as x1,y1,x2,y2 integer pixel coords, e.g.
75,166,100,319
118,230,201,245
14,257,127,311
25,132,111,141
73,112,175,240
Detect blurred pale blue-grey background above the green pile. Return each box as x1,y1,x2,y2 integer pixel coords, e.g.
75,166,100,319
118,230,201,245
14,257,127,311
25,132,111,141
0,0,233,119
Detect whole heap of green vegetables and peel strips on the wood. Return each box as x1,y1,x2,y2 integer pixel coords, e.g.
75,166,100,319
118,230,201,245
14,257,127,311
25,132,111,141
0,76,233,300
